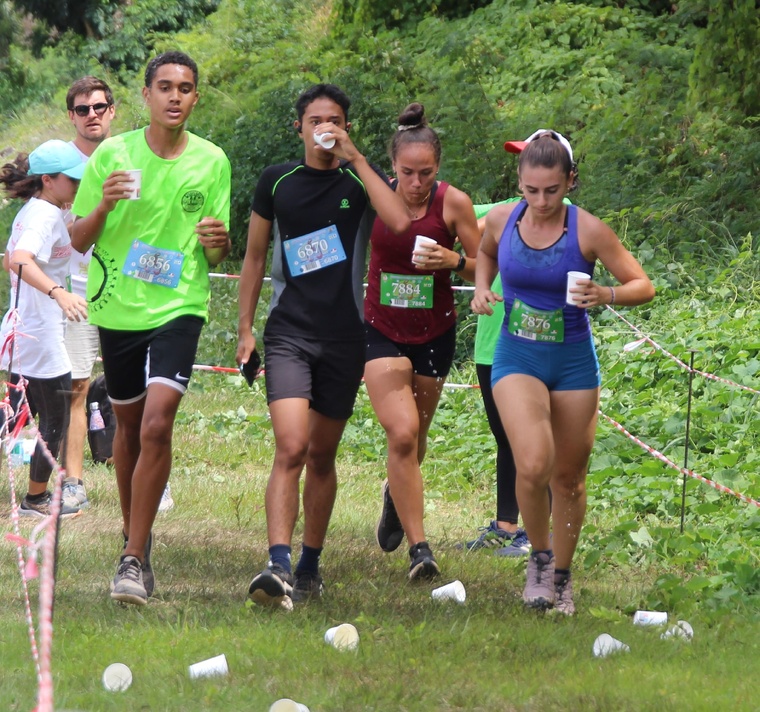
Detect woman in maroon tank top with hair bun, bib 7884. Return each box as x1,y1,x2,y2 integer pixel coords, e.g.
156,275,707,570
364,103,480,580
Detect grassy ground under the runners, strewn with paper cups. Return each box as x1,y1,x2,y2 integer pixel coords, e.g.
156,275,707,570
0,373,760,712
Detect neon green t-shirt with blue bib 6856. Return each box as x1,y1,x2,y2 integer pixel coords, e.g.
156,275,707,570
72,129,230,331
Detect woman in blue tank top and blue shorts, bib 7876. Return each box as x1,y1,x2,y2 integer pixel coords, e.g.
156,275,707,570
472,129,654,615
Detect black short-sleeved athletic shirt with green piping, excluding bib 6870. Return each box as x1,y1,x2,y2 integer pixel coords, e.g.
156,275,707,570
251,162,388,341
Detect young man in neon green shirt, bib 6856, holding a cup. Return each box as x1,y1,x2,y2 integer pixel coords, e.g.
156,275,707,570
71,52,231,605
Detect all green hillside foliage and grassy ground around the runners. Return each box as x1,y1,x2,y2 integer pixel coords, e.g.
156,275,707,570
0,0,760,712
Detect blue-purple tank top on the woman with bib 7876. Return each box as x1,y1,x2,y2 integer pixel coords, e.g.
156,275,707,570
499,200,594,344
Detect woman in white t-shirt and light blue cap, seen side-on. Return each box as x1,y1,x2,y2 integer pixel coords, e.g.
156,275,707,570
0,140,87,517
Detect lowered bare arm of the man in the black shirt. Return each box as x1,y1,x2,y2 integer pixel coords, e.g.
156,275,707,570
235,212,272,364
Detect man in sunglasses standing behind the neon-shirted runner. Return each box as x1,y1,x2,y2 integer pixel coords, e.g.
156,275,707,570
63,76,116,507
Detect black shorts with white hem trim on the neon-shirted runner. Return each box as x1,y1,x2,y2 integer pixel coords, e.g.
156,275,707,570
98,315,203,404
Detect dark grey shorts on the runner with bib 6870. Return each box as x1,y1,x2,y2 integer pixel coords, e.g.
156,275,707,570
264,332,365,420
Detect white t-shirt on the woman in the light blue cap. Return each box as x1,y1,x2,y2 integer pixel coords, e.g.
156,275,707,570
0,198,71,378
